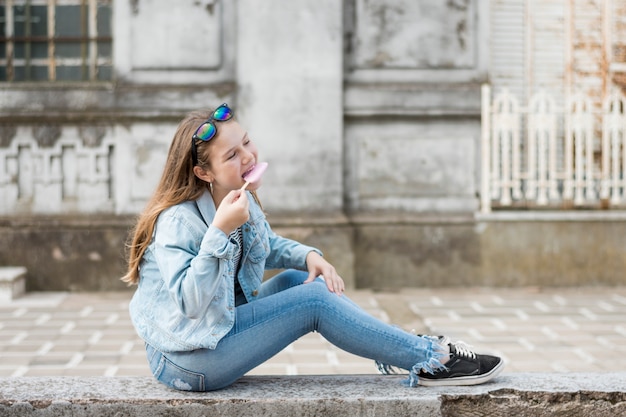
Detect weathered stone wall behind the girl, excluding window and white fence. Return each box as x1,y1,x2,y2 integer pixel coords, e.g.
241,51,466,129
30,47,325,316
0,0,624,290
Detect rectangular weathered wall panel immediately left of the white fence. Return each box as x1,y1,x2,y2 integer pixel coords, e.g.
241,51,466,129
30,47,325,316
346,115,480,214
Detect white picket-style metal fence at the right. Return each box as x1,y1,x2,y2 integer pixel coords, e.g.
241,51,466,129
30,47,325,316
481,85,626,213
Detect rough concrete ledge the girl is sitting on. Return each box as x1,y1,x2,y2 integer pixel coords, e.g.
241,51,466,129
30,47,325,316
0,372,626,417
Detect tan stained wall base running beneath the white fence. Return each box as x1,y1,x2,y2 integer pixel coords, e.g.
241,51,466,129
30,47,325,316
354,217,626,289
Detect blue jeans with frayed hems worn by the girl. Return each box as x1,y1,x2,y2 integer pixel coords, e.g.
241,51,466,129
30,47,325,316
146,270,443,391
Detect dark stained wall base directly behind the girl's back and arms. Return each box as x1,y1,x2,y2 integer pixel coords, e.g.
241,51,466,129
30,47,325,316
0,215,356,291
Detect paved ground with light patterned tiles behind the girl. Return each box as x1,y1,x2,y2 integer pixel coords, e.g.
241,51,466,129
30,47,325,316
0,287,626,377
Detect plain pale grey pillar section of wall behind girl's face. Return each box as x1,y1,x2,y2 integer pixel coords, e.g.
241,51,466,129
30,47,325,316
237,0,343,215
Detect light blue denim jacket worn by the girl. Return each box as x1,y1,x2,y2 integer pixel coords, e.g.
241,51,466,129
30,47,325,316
129,191,319,352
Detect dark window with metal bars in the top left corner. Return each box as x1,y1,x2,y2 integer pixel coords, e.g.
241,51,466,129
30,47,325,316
0,0,113,82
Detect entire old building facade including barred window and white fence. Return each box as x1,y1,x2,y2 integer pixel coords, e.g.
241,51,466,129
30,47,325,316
0,0,626,290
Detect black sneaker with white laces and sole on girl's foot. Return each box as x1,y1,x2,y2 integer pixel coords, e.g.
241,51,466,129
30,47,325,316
418,342,504,387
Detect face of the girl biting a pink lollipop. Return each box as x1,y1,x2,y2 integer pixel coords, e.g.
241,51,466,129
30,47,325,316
200,120,261,195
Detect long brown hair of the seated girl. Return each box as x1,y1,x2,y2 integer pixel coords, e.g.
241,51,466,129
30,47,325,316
122,110,211,285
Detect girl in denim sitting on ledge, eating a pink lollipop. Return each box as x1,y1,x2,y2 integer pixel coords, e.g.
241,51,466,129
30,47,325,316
123,104,503,391
